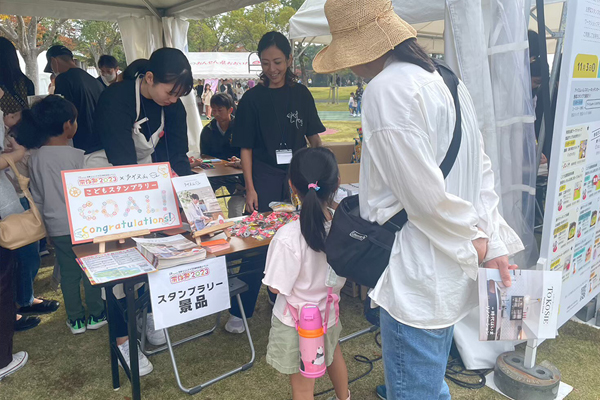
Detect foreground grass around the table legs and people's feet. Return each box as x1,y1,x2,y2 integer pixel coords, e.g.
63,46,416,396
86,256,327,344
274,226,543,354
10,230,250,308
0,256,600,400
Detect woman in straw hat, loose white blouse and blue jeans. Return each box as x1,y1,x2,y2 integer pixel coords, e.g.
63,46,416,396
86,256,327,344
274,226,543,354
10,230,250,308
313,0,522,400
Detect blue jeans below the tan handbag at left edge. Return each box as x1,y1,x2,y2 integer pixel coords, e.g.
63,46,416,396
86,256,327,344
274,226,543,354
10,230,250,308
14,197,41,307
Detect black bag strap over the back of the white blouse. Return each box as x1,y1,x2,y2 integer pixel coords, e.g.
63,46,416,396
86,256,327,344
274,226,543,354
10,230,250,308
383,59,462,232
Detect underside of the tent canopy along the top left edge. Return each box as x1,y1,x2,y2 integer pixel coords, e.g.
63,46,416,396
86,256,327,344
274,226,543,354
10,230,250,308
0,0,263,21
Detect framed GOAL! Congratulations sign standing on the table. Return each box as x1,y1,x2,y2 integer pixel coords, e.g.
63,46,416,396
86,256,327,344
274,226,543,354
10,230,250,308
62,163,181,244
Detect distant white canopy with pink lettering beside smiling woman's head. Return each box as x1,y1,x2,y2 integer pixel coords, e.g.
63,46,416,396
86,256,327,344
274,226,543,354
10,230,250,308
187,52,260,79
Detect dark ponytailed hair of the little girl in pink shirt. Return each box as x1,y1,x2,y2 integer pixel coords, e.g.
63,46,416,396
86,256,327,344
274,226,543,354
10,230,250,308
290,147,339,251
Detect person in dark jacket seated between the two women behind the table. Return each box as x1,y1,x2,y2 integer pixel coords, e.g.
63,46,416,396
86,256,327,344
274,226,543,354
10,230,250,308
200,93,246,218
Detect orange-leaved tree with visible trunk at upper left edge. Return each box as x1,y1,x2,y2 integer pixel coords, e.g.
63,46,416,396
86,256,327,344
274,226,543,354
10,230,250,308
0,15,69,90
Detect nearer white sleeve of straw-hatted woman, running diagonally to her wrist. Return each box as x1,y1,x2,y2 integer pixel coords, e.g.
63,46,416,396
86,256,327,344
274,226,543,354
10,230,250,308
365,125,479,268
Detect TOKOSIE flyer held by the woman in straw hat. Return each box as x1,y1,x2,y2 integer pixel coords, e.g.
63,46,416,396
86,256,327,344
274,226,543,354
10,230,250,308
478,268,562,341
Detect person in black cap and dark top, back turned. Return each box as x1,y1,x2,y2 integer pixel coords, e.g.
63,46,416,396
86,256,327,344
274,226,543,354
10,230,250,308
44,45,104,154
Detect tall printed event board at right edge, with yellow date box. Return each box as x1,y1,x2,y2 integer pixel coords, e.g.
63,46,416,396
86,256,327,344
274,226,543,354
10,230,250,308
540,0,600,326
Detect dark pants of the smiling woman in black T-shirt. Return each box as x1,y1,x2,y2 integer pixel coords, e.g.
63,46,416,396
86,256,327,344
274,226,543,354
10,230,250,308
252,160,290,212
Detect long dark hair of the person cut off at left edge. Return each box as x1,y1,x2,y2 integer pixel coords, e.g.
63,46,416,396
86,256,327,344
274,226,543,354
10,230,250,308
0,37,35,115
